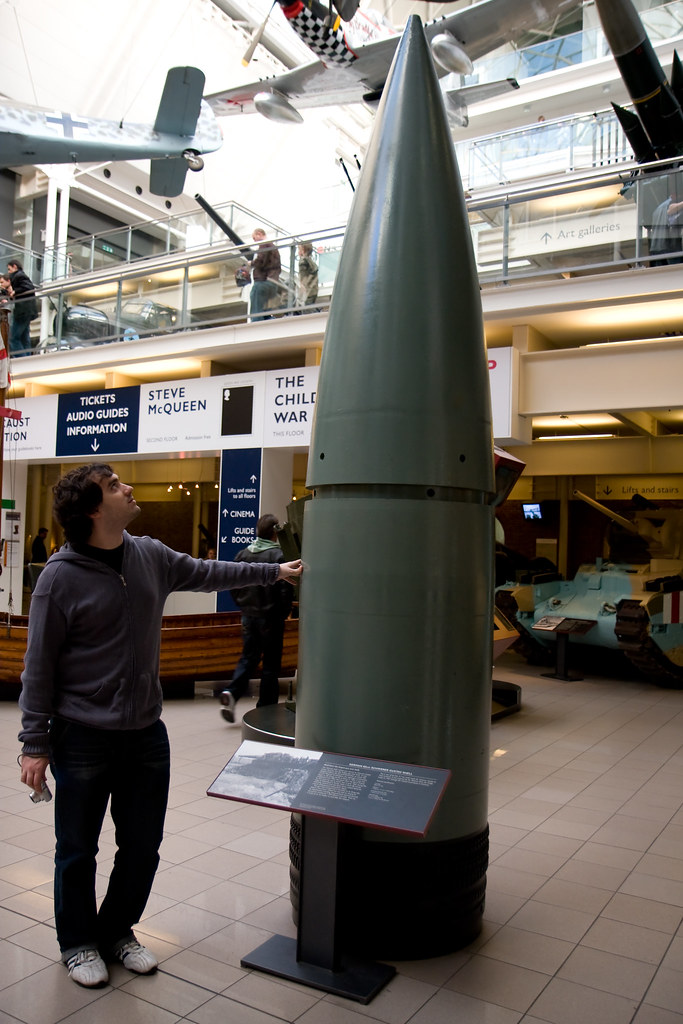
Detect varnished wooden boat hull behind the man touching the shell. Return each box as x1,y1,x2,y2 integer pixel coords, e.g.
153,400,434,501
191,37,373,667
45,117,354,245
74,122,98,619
0,611,299,695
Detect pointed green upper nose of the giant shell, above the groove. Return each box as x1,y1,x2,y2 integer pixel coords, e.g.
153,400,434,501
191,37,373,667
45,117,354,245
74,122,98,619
307,16,493,490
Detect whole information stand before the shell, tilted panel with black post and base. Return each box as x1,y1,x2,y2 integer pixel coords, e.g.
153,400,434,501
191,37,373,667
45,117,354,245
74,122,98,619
207,740,451,1004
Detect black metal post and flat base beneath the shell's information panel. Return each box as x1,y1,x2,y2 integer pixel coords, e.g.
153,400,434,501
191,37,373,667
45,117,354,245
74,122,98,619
240,814,396,1004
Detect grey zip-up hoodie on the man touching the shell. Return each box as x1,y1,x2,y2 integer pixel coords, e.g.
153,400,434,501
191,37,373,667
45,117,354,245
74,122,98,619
18,532,280,754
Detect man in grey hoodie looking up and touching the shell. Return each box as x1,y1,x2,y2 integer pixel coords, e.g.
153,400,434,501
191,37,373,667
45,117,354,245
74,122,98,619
19,463,301,987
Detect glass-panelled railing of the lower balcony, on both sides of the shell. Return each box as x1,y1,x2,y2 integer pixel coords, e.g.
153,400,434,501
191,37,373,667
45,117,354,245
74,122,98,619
12,155,683,351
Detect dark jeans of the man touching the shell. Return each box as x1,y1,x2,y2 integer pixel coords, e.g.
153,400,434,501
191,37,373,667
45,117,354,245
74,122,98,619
50,719,170,961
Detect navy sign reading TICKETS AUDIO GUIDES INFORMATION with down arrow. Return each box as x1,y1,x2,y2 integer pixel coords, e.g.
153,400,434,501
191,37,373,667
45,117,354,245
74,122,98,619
55,387,140,459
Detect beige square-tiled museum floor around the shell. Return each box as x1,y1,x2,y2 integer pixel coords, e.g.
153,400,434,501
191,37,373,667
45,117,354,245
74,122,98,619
0,653,683,1024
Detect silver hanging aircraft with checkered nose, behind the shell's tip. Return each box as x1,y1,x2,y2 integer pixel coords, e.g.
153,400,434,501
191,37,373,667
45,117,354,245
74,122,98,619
206,0,579,127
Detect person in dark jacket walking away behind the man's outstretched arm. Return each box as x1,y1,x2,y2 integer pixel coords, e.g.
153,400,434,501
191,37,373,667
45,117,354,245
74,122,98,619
220,512,293,722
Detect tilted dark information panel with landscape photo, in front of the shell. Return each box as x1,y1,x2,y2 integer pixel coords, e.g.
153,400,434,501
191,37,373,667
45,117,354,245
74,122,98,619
207,739,451,836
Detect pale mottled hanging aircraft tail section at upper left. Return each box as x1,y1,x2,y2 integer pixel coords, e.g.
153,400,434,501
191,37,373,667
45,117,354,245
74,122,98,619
0,68,222,196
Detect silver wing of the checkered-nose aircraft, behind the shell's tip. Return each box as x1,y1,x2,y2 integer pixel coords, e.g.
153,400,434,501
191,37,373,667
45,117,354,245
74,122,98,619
206,0,578,117
